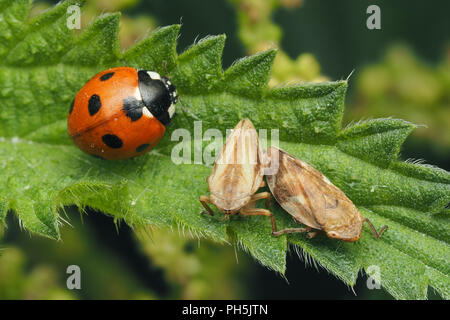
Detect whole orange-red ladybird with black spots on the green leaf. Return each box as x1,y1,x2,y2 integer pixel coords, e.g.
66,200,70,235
67,67,178,160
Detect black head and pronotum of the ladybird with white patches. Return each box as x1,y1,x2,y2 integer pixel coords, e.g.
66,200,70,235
138,70,178,125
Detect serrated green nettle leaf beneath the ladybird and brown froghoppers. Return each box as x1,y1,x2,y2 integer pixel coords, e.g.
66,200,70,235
0,0,450,299
